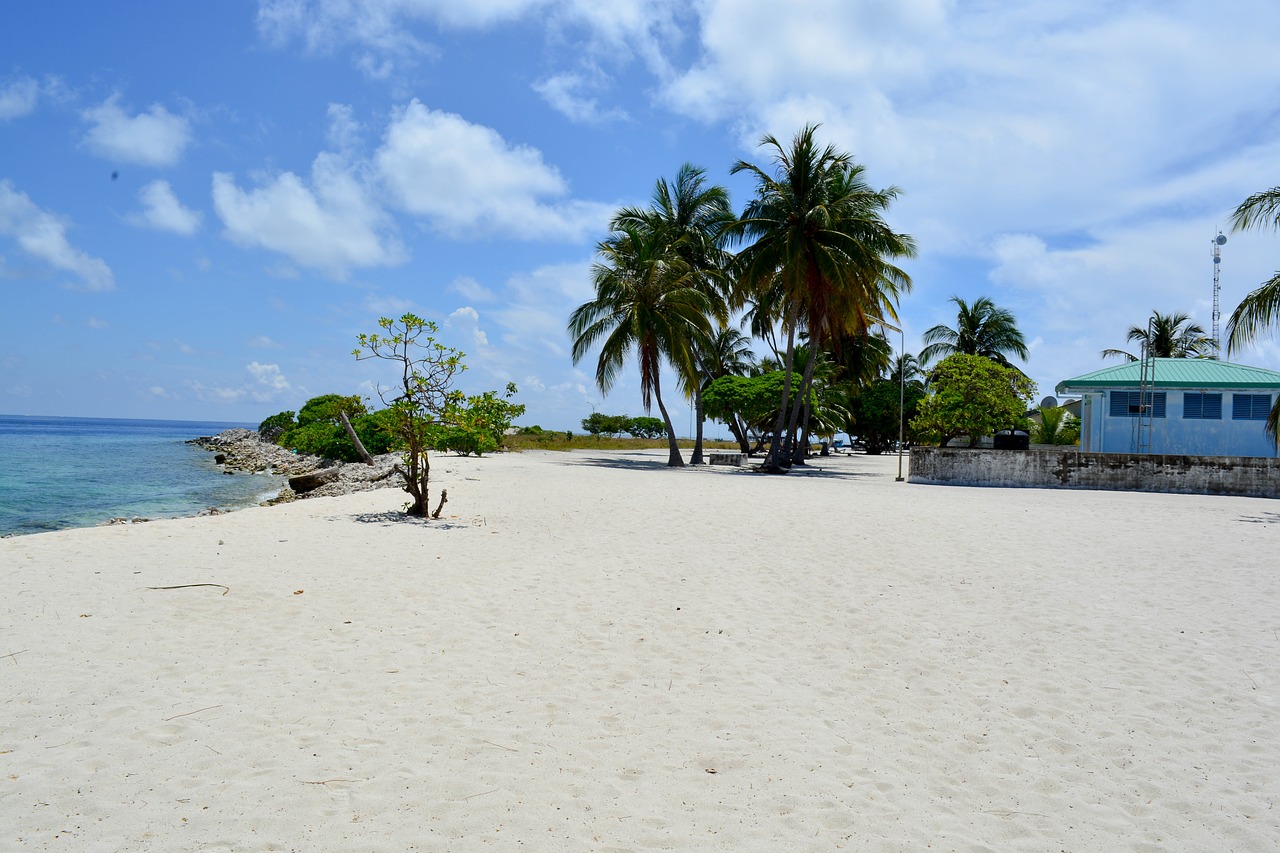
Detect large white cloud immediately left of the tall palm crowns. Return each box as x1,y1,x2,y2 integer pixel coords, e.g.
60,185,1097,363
375,100,613,241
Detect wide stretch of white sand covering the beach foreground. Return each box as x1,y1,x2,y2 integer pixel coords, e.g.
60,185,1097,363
0,452,1280,853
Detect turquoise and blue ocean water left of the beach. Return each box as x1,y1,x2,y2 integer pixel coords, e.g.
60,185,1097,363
0,415,285,535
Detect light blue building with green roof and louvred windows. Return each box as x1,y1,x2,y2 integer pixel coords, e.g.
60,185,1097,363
1057,359,1280,457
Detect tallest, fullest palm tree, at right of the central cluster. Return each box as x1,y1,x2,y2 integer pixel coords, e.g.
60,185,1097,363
726,124,915,471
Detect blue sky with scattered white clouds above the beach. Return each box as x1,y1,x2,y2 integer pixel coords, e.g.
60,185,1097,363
0,0,1280,429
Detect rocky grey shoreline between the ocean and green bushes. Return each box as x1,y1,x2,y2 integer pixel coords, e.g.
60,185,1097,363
187,429,399,505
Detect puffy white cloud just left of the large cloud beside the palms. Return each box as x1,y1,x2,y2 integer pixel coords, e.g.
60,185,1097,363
214,154,406,278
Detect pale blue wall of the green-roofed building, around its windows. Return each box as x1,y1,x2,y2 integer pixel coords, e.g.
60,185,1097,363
1080,386,1280,457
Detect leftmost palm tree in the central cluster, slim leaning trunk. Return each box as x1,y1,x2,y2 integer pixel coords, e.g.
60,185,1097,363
568,224,710,466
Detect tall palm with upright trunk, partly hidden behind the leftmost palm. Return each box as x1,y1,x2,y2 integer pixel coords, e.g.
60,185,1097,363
612,163,733,465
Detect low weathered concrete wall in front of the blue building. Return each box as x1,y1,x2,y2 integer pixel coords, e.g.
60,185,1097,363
908,447,1280,498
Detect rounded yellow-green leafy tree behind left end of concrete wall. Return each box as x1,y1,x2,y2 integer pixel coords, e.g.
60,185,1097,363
911,353,1036,447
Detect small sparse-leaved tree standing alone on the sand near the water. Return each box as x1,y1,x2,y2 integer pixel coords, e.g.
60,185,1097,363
353,314,466,519
